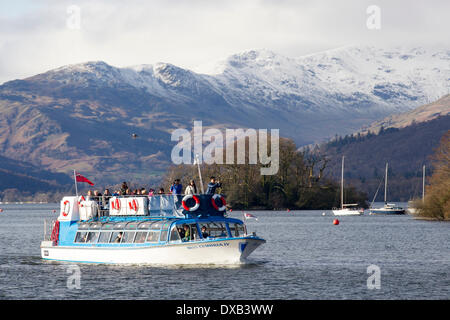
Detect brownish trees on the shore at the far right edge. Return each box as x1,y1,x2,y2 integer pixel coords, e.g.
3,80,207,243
415,130,450,220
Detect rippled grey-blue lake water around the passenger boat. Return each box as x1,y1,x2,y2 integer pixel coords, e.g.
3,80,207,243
0,204,450,300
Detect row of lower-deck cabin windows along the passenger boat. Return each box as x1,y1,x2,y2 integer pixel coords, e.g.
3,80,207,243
75,222,245,243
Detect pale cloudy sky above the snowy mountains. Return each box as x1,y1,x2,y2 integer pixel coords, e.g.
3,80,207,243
0,0,450,83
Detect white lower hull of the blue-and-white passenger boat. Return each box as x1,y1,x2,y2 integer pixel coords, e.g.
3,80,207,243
41,238,265,265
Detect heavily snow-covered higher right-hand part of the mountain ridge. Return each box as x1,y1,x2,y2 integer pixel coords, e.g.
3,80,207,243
204,47,450,113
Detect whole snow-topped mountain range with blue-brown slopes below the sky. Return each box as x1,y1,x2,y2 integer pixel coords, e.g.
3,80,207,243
0,46,450,181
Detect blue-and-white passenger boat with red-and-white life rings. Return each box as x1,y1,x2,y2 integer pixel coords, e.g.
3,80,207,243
41,194,266,265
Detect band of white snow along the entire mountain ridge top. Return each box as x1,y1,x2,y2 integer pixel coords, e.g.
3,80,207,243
20,46,450,113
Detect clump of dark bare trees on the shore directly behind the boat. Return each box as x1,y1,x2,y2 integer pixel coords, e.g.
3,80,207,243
163,139,367,209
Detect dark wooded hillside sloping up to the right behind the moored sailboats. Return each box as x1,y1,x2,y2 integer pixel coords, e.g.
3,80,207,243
320,92,450,201
